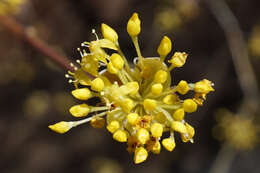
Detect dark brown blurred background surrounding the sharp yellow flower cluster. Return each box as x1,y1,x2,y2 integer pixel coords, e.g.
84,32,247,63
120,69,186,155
0,0,260,173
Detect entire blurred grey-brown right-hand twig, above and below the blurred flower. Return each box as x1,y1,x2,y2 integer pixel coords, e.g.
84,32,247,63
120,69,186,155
206,0,259,173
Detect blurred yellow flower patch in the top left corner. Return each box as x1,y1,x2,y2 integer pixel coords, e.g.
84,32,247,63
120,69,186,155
0,0,25,15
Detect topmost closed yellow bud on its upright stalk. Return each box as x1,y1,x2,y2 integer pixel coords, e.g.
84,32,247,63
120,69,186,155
127,13,141,37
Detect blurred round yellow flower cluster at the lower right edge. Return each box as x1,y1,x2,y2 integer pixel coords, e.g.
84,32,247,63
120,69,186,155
213,109,260,150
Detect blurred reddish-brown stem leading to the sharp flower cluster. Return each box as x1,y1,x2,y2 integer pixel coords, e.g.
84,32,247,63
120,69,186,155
0,16,74,71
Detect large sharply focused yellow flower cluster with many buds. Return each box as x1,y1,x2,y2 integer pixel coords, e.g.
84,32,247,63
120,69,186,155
49,13,214,164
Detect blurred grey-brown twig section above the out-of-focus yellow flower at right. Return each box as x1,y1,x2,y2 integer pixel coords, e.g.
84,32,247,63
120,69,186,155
206,0,259,114
